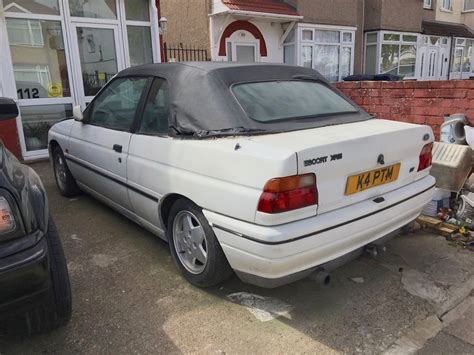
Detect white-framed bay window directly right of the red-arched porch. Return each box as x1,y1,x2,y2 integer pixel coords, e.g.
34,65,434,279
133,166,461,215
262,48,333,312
297,24,355,82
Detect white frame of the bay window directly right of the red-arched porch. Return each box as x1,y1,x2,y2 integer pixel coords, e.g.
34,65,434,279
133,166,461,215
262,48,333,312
295,23,356,82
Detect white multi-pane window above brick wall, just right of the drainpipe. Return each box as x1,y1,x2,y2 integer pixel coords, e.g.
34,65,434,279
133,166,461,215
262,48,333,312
364,31,419,79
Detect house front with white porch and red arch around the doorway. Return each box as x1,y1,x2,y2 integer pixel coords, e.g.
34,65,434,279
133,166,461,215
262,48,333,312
162,0,303,63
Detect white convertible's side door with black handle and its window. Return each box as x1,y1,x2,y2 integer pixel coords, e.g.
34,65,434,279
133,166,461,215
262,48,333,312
66,77,148,210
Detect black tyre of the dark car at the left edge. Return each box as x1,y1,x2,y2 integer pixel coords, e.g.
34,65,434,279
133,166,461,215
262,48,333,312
6,217,72,336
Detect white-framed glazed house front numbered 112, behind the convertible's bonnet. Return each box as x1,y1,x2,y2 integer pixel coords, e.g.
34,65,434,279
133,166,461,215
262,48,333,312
0,0,165,160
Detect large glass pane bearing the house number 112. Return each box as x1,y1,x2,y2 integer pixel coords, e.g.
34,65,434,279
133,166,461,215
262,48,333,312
6,18,71,99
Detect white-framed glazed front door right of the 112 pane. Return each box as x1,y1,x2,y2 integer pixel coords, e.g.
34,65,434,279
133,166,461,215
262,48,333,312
72,22,125,109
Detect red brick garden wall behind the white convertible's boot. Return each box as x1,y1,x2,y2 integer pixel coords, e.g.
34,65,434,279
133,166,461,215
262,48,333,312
337,80,474,140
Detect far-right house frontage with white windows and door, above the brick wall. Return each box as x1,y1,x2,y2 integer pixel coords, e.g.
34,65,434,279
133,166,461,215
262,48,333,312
364,0,474,80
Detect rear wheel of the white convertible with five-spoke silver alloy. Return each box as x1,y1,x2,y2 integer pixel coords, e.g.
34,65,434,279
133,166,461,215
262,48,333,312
167,199,233,287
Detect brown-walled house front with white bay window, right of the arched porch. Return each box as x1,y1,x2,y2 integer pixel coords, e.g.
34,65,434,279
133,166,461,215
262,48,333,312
284,0,364,82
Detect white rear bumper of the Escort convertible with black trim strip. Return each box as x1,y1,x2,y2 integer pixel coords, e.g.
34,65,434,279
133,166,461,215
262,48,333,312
204,176,435,287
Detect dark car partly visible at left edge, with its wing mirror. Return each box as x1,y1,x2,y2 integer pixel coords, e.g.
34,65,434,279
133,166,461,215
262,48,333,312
0,98,71,335
